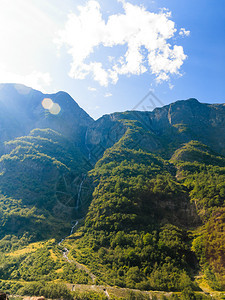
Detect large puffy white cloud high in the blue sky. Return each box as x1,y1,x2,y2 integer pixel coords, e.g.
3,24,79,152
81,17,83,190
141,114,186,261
56,0,189,86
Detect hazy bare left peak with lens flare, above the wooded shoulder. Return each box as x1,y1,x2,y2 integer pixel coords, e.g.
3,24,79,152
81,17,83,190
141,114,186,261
0,84,93,145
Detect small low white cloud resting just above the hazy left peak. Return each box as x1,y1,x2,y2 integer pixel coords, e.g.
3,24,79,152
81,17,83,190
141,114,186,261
0,68,52,92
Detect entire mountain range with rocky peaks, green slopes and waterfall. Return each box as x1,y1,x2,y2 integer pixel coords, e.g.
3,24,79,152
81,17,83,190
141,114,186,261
0,84,225,299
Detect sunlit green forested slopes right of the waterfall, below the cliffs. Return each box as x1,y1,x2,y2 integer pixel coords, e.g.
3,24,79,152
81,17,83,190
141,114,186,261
64,141,225,291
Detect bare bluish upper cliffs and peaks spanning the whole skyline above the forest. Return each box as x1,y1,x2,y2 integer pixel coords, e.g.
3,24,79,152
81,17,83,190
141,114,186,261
0,84,225,160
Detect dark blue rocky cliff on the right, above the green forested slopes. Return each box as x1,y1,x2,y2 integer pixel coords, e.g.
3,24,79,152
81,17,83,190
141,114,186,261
86,99,225,157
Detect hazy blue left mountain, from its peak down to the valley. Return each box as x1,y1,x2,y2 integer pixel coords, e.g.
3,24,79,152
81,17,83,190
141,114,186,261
0,84,93,248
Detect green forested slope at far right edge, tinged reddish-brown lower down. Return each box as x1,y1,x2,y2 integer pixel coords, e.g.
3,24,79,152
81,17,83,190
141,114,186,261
171,141,225,290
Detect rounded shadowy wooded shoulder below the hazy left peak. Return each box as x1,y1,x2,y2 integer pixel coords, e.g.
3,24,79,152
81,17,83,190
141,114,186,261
0,129,93,220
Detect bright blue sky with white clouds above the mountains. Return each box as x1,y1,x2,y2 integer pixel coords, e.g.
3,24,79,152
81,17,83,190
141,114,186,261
0,0,225,118
